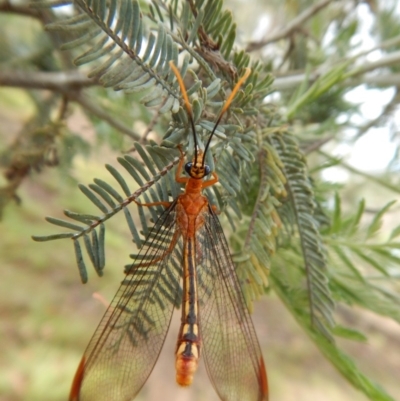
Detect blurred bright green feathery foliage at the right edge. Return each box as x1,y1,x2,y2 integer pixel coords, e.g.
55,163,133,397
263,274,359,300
324,195,400,322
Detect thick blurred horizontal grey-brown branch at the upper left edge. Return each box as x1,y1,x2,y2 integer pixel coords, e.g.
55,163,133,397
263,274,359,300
0,70,98,92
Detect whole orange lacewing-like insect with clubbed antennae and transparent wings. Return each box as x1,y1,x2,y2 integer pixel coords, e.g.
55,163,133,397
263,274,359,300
70,62,268,401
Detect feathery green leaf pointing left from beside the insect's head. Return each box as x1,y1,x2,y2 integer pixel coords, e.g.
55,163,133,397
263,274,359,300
33,144,179,282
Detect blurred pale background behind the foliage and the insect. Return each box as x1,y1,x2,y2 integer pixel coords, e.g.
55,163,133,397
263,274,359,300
0,0,400,401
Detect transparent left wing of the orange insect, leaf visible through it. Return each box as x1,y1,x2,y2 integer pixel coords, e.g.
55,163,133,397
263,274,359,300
70,203,182,401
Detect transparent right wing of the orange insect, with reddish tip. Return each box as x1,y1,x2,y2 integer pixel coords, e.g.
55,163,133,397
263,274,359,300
196,207,268,401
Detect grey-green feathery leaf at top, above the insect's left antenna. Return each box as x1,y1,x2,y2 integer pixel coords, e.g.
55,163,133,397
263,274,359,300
43,0,179,113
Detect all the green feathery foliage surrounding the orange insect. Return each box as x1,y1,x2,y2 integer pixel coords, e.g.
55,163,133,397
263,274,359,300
1,0,400,400
